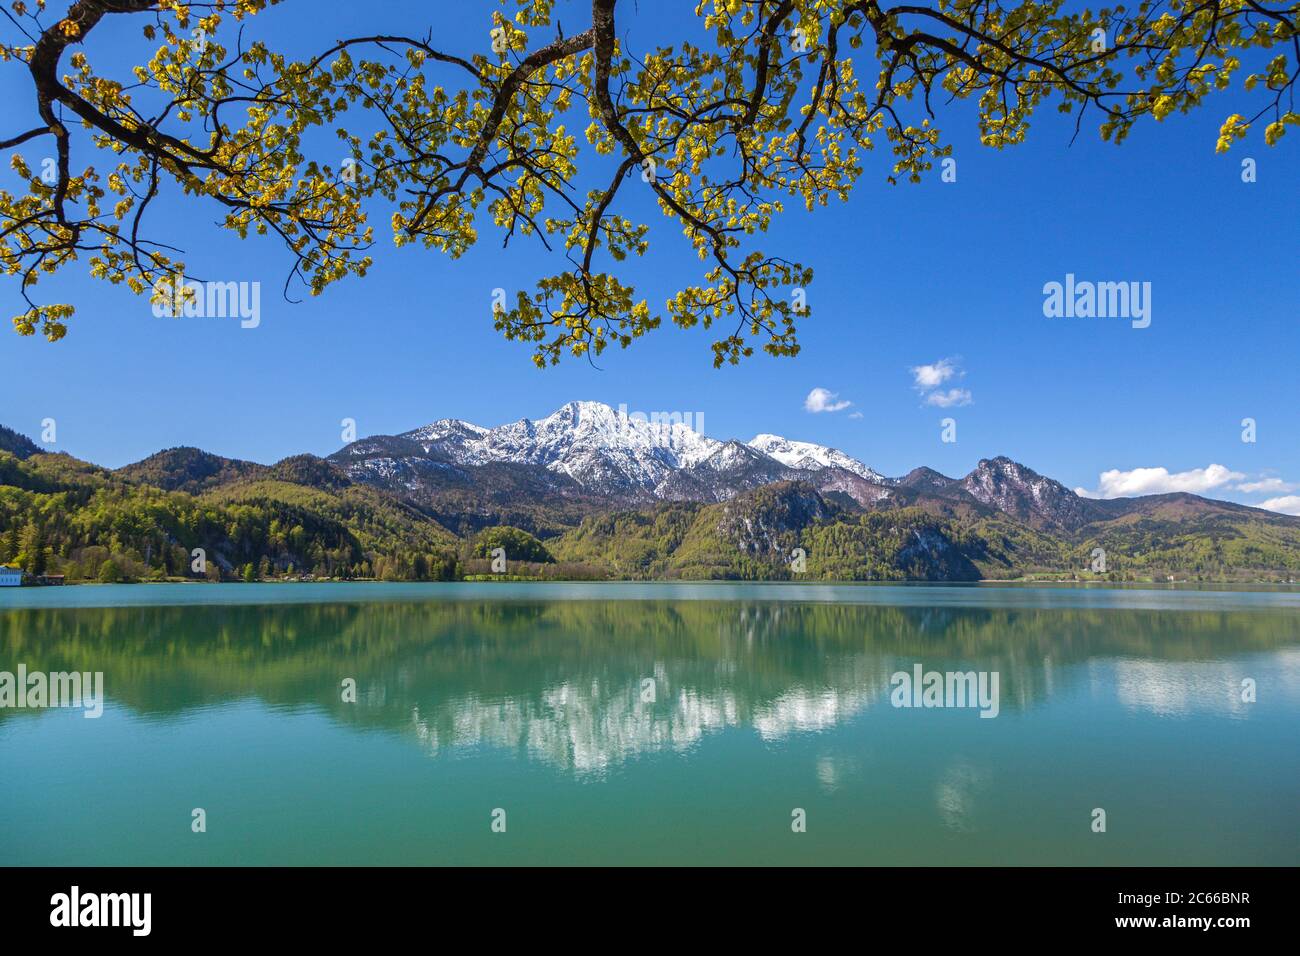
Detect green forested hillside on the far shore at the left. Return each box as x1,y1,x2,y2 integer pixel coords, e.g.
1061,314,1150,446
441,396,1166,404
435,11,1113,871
0,453,456,581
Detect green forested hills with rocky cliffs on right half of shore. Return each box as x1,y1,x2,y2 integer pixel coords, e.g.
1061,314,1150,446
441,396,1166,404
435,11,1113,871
547,483,1300,581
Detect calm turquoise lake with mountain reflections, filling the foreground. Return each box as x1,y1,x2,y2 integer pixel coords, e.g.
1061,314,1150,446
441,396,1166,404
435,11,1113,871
0,583,1300,865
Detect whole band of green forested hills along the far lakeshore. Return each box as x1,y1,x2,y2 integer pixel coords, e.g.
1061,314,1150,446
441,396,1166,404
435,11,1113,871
0,442,1300,583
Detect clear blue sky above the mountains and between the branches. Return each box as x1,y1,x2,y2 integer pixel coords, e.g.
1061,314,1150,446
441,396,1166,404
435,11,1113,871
0,3,1300,515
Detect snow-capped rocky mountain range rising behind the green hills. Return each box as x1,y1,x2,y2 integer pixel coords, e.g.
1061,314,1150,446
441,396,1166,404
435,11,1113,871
329,402,1269,532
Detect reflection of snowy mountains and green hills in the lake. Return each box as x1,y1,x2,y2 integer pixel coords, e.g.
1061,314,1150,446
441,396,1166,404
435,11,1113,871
0,600,1300,780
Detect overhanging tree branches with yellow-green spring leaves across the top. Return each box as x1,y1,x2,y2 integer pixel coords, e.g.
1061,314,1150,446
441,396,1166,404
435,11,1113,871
0,0,1300,365
